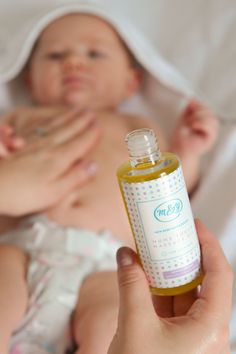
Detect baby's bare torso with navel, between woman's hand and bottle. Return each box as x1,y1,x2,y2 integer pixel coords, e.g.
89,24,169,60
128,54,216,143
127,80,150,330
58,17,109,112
46,121,131,233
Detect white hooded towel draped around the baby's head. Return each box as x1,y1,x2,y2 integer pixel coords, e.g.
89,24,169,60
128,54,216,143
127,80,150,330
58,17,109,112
0,0,194,136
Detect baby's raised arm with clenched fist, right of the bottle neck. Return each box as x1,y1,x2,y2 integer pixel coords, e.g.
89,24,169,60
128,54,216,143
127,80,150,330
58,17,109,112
169,99,219,192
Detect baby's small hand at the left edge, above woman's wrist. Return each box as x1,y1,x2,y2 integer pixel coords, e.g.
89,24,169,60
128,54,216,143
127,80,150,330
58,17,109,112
0,124,24,159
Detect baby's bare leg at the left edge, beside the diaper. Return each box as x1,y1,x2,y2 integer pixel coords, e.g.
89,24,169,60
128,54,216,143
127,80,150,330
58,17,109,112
0,245,27,354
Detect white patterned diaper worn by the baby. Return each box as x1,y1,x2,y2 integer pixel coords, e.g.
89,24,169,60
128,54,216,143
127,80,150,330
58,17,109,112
0,216,121,354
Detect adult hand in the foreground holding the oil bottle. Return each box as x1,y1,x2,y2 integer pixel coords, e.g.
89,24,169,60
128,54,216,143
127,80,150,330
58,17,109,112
108,221,233,354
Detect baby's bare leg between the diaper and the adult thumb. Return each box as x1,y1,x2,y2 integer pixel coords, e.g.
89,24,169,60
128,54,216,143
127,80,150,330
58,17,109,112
73,272,119,354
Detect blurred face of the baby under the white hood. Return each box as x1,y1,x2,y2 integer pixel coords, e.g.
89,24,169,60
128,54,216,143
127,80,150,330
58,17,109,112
28,14,138,109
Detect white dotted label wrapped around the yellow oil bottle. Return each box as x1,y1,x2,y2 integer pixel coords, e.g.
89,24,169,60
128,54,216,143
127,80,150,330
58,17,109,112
121,167,200,288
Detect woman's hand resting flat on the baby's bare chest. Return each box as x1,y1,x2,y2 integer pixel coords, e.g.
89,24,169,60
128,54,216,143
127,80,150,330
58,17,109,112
0,112,100,216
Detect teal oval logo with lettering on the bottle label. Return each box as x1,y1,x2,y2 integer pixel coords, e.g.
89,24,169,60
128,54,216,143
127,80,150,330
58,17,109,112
154,199,183,222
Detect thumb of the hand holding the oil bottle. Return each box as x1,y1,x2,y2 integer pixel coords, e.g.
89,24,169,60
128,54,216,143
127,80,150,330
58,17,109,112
117,247,157,327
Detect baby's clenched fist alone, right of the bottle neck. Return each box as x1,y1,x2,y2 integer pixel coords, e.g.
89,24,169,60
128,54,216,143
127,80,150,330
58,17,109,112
171,99,219,156
